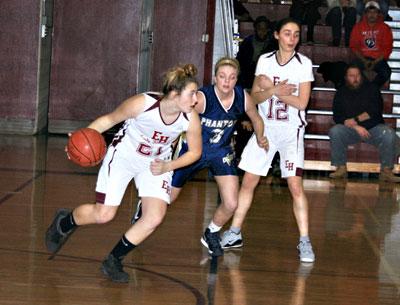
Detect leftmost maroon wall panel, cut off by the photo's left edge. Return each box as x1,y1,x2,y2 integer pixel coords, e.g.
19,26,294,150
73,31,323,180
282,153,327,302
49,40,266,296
0,0,40,120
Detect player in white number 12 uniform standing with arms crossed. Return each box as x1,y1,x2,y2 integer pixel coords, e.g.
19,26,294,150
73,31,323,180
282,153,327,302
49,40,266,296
221,18,315,262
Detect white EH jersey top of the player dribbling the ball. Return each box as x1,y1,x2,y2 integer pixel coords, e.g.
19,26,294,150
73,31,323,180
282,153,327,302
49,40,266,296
111,93,190,163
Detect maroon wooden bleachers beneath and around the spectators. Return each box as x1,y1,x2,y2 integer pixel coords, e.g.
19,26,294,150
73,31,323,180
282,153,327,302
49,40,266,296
239,1,400,173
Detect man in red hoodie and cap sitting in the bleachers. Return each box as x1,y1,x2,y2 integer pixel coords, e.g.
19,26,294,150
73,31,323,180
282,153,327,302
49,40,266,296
350,1,393,87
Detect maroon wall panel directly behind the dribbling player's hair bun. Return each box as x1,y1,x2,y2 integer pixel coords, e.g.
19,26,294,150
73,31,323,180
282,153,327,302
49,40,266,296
151,0,207,90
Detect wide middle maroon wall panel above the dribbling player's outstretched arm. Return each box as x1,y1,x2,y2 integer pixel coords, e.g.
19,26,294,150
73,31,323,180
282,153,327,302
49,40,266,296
49,0,142,122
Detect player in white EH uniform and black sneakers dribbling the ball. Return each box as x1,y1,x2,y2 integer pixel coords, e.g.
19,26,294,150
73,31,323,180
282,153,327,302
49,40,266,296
46,64,202,282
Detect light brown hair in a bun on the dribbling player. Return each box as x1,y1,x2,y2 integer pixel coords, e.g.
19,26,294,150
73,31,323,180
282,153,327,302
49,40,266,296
162,64,198,95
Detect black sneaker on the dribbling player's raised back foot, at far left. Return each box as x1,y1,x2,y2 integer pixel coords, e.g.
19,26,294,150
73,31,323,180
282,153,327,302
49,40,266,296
46,209,76,254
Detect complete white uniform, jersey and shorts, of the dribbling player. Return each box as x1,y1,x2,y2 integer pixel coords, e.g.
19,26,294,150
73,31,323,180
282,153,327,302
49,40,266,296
96,93,190,206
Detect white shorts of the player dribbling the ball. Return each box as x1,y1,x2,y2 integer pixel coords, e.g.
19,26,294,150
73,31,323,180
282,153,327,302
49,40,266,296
96,147,172,206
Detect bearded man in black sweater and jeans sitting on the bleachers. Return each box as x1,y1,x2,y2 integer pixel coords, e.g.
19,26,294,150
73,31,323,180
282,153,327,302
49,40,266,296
329,64,400,183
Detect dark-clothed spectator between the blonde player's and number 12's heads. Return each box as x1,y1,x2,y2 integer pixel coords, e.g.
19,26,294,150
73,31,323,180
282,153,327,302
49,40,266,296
236,16,276,89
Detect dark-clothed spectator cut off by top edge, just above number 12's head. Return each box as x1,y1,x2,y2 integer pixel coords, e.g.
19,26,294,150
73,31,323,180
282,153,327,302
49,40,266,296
289,0,323,45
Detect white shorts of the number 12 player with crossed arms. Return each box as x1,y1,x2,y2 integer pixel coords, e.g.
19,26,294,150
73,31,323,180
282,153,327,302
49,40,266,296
239,126,304,178
